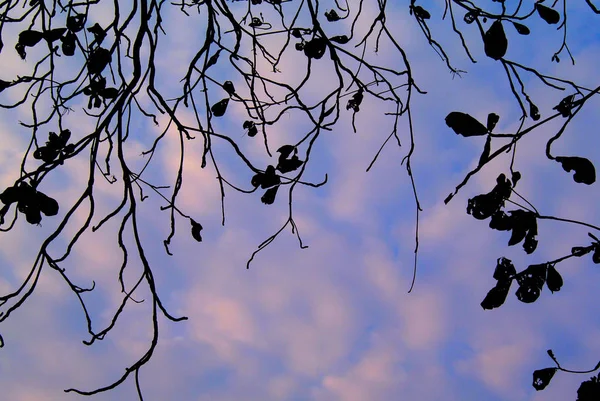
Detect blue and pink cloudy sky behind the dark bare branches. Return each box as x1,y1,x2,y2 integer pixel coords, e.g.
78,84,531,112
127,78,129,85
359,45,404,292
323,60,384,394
0,2,600,401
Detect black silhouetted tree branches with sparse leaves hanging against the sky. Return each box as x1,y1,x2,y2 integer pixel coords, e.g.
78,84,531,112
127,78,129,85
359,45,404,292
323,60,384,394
0,0,600,401
